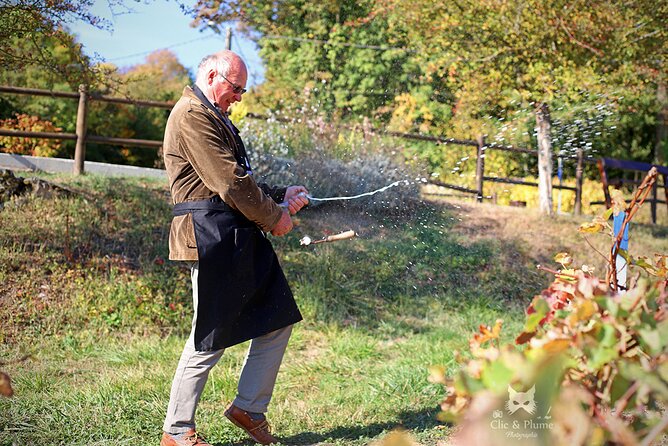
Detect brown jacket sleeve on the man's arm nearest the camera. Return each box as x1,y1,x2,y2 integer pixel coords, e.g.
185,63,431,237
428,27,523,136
179,105,283,231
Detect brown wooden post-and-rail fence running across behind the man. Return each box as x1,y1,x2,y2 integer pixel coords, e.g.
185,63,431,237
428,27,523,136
0,85,668,223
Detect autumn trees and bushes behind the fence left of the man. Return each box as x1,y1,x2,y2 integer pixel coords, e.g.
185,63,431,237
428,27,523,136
0,20,191,167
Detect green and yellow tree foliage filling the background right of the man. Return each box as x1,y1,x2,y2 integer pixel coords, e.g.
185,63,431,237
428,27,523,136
194,0,668,196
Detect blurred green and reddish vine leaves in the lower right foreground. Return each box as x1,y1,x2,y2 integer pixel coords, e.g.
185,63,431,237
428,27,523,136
432,176,668,445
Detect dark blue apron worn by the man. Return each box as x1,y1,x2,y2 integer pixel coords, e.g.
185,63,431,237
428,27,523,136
173,89,302,351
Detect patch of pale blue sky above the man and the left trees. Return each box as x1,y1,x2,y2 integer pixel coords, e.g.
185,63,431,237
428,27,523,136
67,0,264,86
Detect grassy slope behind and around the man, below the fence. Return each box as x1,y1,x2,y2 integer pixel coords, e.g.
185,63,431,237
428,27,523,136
0,172,668,445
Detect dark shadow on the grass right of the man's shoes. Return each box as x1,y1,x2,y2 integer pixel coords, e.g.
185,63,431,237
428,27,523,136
220,407,448,446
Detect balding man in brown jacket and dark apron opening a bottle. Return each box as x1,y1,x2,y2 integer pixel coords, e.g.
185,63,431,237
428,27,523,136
160,51,308,446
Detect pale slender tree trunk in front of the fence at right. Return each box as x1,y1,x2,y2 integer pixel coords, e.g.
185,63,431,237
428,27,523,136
536,103,552,215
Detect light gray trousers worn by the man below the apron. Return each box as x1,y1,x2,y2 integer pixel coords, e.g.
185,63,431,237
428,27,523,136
162,263,292,434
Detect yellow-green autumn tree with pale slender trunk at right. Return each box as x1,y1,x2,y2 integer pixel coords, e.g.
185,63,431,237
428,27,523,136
370,0,668,212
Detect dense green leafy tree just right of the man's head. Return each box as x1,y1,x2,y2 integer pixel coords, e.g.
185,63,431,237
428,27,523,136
189,0,422,121
